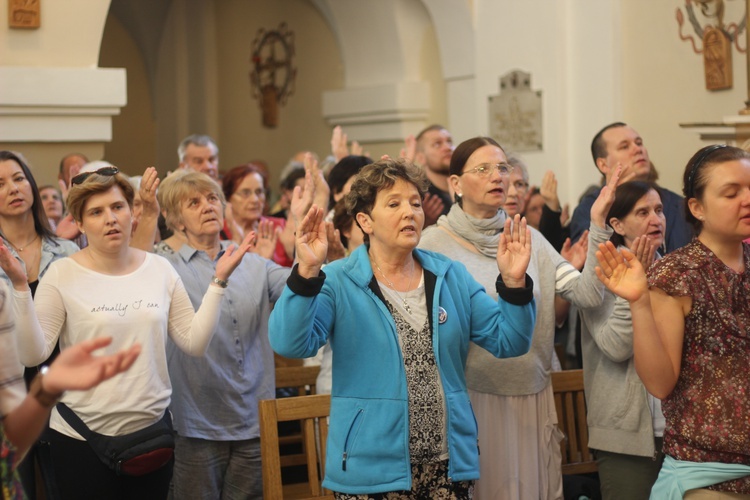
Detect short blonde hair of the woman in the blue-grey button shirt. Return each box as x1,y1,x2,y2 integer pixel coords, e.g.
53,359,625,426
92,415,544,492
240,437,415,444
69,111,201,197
156,169,227,231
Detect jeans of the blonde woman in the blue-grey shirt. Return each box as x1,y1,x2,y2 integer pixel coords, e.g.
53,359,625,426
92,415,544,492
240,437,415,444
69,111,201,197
171,436,263,500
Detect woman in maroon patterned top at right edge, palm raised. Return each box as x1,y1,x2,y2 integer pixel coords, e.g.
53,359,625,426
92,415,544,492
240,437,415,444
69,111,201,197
597,145,750,500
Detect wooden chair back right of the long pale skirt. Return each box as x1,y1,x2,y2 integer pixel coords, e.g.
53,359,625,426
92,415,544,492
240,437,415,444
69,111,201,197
552,370,597,474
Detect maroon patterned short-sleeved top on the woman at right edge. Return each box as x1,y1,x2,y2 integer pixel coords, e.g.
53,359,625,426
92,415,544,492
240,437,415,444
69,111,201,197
648,239,750,493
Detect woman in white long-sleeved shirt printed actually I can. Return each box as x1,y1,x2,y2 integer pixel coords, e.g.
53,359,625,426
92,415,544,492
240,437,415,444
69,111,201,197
0,167,252,499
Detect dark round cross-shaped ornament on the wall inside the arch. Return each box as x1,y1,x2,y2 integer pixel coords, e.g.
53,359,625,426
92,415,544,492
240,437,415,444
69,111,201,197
250,23,297,128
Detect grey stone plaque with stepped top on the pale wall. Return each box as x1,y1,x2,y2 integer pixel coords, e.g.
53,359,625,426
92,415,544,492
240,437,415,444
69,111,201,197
489,70,542,152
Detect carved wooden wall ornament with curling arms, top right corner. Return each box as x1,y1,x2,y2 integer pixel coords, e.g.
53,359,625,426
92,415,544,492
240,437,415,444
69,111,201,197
677,0,747,90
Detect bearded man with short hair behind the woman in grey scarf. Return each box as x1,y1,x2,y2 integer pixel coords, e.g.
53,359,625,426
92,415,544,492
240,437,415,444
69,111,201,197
414,124,454,227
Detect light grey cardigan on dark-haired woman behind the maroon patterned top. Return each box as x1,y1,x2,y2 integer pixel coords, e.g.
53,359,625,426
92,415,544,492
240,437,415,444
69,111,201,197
580,291,655,457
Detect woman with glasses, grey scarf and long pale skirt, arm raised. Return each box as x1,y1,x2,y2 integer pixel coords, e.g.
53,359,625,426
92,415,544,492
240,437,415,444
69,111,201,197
419,137,617,500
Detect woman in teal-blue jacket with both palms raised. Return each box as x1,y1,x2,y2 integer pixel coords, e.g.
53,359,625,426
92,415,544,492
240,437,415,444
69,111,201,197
269,159,535,498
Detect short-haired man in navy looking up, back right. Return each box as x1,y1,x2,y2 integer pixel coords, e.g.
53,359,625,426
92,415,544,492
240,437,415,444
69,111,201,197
570,122,693,253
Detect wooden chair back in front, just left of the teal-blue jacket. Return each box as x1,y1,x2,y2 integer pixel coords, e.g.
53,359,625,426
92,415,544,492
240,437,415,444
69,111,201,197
259,395,333,500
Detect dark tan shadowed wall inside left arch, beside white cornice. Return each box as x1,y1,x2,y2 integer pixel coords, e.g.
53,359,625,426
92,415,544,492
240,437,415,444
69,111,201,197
99,15,156,175
